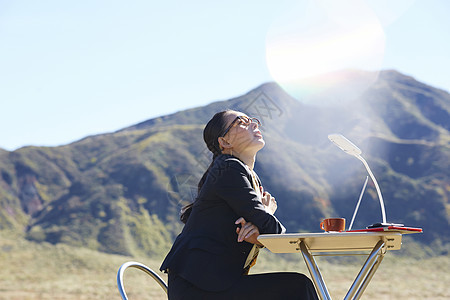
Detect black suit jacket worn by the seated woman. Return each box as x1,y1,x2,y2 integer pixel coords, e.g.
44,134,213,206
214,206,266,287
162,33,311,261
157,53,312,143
160,155,285,291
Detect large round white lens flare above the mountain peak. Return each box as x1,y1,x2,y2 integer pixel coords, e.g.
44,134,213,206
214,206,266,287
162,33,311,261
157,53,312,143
266,0,385,105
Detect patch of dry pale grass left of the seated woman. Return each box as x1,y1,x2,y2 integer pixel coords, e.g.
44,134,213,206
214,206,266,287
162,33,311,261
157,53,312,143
0,235,164,300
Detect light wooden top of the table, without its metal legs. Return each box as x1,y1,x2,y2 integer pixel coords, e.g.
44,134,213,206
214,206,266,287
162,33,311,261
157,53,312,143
258,231,402,253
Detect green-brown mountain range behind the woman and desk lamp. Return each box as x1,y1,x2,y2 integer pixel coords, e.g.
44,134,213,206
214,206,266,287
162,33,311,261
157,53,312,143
0,70,450,255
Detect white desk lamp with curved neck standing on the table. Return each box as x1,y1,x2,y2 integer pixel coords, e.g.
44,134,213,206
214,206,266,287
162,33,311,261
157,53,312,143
328,134,403,228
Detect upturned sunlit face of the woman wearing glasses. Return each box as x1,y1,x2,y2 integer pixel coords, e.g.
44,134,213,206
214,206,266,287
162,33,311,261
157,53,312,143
223,111,265,153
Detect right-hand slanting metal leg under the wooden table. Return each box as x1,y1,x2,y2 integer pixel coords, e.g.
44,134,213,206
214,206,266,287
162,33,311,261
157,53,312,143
344,240,384,300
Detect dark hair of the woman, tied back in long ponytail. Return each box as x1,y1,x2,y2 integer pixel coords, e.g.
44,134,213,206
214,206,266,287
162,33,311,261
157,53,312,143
180,110,232,223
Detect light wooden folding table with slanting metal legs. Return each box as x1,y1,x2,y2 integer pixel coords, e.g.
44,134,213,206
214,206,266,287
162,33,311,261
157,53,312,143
258,231,402,300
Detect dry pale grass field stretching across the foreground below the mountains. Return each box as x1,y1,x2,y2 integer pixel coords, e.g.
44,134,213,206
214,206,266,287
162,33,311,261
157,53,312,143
0,234,450,300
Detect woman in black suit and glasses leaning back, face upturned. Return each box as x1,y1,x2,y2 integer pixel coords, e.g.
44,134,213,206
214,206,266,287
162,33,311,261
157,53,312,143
160,110,317,300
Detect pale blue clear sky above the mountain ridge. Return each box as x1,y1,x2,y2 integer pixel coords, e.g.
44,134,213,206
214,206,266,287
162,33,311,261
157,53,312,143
0,0,450,150
